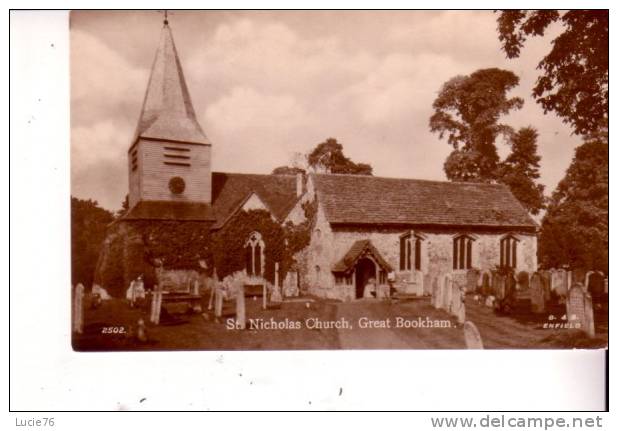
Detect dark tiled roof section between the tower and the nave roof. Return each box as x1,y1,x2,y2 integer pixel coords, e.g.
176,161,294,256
212,172,298,228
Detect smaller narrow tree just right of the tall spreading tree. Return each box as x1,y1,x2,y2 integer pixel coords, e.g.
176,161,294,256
498,127,545,215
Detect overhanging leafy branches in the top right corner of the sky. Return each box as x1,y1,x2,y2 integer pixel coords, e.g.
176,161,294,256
498,10,609,135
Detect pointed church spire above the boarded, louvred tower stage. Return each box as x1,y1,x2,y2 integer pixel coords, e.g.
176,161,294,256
133,20,210,144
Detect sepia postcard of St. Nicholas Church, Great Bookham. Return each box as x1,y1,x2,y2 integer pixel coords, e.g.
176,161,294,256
67,10,609,351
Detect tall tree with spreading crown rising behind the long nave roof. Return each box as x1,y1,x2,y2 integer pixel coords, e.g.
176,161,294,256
429,68,524,182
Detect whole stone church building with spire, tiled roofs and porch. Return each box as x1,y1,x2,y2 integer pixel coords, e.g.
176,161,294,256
95,20,538,301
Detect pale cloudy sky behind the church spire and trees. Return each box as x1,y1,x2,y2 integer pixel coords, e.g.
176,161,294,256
71,11,580,213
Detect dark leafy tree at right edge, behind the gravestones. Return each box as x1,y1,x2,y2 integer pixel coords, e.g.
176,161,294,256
539,130,609,273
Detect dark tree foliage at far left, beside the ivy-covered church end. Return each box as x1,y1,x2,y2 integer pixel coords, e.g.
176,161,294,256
71,196,114,287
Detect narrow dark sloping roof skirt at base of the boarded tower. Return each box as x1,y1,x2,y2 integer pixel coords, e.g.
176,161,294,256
123,201,215,222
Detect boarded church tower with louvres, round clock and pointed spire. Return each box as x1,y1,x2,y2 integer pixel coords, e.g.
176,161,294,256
128,19,212,214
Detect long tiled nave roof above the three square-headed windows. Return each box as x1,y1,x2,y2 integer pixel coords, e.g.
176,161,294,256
312,174,537,228
